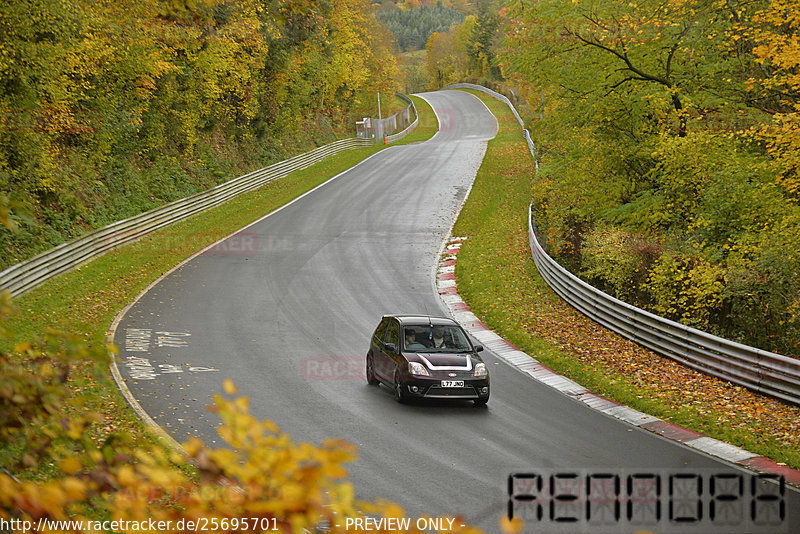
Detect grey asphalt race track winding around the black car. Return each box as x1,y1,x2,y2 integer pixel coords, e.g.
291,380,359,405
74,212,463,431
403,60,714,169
115,91,800,532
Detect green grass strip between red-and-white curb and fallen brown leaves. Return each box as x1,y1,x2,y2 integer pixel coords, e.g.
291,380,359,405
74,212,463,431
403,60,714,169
453,91,800,468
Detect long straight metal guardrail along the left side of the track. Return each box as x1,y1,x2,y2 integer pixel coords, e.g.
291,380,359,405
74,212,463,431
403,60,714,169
0,138,373,296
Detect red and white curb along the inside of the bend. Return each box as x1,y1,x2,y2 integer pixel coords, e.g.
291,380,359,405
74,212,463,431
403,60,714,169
436,237,800,486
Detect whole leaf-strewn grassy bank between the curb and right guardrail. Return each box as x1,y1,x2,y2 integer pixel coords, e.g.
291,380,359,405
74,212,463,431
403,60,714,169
453,93,800,468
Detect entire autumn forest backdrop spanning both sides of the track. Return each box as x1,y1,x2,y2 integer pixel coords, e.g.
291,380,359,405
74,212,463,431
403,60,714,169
0,0,800,355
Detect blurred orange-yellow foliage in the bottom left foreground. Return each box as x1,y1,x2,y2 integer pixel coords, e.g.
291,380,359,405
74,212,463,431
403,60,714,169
0,348,488,533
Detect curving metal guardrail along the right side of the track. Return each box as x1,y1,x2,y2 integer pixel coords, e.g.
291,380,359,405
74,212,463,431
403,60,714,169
451,84,800,404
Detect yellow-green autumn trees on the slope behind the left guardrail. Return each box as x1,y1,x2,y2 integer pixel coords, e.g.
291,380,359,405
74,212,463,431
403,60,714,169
0,0,398,268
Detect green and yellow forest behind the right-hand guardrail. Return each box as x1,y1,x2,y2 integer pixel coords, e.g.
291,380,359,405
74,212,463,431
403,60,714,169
412,0,800,356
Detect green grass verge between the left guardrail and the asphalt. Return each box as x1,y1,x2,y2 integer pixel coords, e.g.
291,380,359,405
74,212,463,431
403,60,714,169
0,97,438,478
